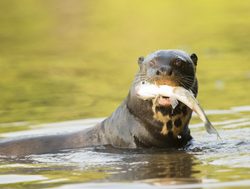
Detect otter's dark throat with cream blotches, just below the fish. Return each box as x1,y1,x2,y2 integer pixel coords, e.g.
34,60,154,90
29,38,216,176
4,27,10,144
127,88,192,138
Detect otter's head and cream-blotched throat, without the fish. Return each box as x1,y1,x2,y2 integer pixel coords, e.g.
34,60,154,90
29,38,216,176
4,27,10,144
127,50,198,146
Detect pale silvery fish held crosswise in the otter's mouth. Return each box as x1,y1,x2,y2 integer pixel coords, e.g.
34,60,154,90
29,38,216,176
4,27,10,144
135,82,220,138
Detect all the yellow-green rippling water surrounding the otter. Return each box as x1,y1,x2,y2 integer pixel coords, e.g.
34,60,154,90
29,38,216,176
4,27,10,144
0,0,250,189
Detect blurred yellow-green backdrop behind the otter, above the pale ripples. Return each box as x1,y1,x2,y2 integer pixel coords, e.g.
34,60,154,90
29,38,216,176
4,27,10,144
0,0,250,123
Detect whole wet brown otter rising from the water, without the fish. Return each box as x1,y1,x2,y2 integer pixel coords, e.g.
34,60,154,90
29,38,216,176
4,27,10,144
0,50,198,156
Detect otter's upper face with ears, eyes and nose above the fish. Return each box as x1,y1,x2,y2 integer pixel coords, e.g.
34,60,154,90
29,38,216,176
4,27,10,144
138,50,198,89
